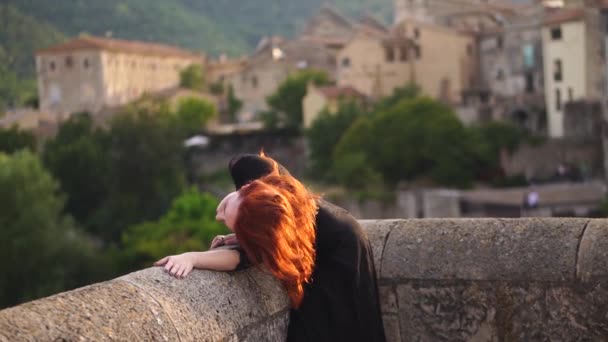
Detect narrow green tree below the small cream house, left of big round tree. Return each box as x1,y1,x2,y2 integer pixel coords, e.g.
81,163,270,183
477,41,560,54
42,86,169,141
306,101,366,177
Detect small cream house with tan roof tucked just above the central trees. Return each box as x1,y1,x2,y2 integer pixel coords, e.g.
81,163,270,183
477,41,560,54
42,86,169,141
302,82,367,128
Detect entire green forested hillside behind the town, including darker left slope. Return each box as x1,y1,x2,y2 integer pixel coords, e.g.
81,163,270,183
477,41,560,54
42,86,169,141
0,0,393,108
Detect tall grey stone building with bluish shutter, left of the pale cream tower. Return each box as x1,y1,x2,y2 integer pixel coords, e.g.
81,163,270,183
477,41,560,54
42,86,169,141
477,4,546,132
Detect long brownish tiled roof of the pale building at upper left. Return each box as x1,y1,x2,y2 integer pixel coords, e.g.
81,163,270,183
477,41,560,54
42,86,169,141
37,37,202,58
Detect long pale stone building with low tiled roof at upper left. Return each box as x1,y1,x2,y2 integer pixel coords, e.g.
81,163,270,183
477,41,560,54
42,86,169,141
36,37,204,114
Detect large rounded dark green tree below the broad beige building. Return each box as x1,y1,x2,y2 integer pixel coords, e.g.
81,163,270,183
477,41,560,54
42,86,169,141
334,98,474,187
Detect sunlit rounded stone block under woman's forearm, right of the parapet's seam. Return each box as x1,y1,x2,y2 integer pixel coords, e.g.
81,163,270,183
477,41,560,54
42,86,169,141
119,267,279,341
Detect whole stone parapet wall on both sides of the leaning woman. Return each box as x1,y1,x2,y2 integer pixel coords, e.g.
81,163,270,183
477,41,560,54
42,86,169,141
0,219,608,341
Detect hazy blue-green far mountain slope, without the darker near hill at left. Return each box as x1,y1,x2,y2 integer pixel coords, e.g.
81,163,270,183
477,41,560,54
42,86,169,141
9,0,393,55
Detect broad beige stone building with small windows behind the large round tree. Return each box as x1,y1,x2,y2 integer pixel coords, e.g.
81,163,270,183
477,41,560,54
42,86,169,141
338,19,475,104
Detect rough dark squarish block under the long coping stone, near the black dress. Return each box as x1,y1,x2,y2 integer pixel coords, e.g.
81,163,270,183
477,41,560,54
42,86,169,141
397,283,498,341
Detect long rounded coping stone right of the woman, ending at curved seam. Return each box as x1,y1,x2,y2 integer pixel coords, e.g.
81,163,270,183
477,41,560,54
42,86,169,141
381,219,587,281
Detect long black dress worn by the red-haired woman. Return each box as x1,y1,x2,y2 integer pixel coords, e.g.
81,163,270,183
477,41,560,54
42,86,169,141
230,155,385,342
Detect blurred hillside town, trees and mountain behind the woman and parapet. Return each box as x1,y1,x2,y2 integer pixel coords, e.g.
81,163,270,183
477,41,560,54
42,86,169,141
0,0,608,308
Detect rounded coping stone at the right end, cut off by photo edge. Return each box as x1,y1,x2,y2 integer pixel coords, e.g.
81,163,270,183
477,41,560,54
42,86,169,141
577,220,608,281
